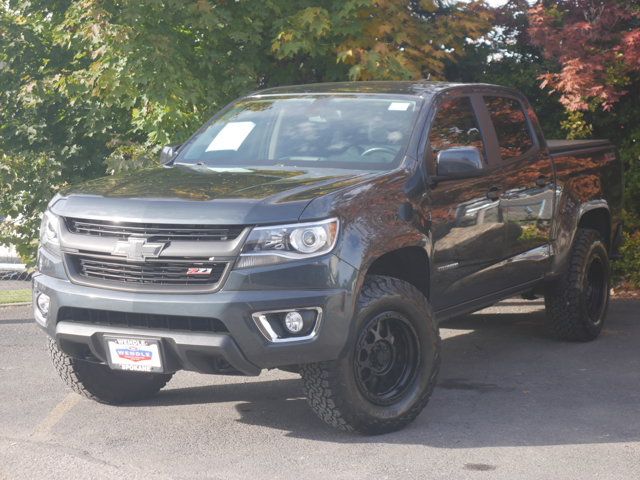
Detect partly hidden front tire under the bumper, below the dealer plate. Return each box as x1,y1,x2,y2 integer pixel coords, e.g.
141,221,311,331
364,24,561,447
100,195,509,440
48,338,172,405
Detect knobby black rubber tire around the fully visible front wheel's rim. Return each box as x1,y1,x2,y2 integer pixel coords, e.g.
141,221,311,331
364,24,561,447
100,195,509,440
301,275,440,435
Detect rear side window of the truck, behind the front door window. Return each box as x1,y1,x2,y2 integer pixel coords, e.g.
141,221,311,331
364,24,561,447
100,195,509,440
484,97,533,160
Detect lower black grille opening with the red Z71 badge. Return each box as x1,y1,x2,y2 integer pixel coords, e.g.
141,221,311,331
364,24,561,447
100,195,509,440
69,255,227,286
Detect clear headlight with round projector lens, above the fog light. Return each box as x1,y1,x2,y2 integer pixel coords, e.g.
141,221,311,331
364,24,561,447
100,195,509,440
236,218,339,268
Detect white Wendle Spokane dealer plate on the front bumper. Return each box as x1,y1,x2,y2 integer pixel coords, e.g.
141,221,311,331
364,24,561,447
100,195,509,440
105,337,163,372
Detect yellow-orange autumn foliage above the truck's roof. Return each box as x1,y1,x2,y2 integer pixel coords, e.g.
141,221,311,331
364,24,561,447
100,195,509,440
273,0,492,80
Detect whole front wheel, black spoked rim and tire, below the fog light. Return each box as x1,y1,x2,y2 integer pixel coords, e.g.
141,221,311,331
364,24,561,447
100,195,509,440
301,275,440,434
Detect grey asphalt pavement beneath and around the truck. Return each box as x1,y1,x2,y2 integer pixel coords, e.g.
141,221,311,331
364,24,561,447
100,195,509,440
0,299,640,480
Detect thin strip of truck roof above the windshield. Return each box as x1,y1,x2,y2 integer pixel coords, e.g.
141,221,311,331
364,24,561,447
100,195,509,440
249,80,505,97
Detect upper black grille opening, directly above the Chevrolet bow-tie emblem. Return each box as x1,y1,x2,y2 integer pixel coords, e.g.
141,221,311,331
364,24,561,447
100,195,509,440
65,218,244,242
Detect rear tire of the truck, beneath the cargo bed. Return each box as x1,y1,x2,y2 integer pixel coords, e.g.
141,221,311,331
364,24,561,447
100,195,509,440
544,228,610,342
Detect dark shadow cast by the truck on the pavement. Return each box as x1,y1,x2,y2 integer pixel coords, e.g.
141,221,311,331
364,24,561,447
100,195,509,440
147,301,640,448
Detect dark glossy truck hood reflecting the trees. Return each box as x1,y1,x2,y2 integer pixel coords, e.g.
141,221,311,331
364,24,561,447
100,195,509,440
51,165,380,225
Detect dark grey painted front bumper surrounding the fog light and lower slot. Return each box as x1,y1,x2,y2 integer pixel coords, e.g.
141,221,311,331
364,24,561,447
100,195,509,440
33,251,357,375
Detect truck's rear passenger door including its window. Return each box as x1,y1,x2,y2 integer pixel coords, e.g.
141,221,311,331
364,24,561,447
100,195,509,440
483,93,554,286
